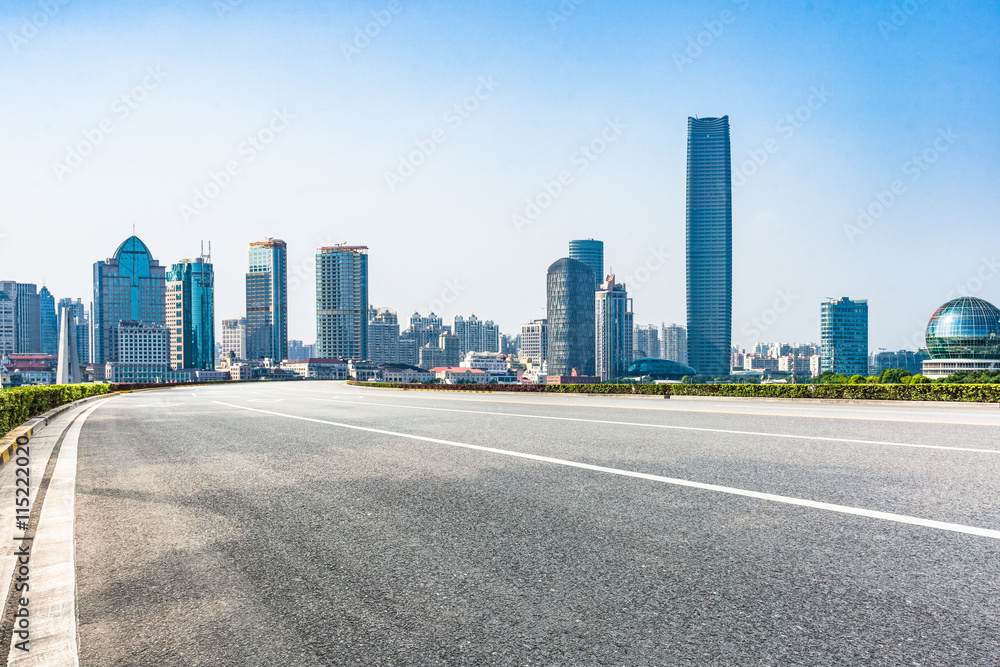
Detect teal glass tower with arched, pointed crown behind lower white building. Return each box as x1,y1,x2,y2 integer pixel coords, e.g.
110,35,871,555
91,236,167,364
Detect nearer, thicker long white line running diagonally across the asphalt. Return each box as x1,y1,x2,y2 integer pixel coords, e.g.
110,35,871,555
214,401,1000,540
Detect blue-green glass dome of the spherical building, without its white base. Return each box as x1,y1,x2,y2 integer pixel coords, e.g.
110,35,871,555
926,296,1000,359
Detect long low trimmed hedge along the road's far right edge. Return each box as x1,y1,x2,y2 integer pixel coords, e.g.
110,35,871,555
348,381,1000,403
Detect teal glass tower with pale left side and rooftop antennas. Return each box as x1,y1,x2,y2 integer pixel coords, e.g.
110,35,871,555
167,250,215,371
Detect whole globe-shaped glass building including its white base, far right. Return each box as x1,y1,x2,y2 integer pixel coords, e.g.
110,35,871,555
922,296,1000,379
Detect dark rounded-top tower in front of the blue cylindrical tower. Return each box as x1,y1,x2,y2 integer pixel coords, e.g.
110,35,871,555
546,257,595,376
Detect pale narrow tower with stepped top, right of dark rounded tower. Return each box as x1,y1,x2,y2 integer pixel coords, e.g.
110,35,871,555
594,274,633,380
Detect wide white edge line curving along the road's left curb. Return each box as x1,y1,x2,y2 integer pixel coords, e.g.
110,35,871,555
7,399,114,667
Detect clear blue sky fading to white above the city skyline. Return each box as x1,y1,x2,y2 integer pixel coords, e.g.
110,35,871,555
0,0,1000,349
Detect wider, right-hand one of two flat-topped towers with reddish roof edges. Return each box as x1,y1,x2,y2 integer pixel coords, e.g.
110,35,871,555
316,246,368,361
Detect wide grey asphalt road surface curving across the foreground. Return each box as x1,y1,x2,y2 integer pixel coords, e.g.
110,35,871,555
64,382,1000,666
